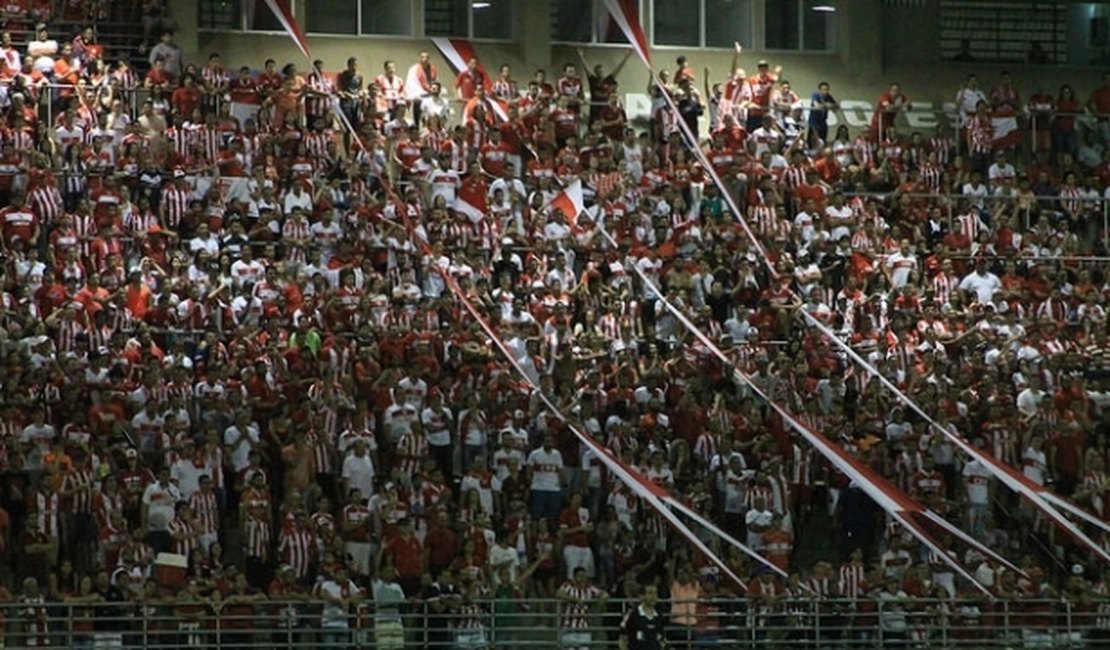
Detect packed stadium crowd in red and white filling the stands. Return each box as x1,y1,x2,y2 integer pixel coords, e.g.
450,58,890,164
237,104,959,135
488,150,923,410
0,3,1110,648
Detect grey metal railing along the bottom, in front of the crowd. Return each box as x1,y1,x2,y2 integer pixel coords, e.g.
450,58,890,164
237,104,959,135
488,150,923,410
0,596,1110,649
